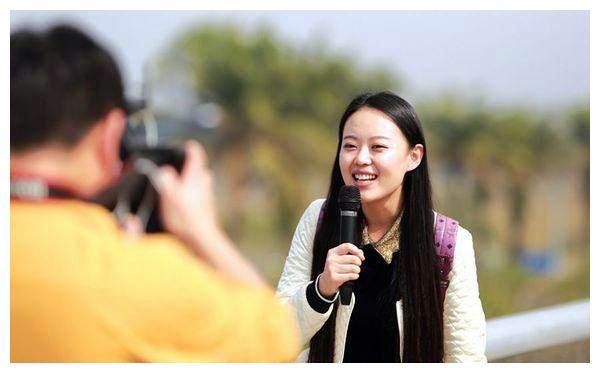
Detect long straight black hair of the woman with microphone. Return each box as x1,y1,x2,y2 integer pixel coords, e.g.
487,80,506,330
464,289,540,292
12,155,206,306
309,92,444,362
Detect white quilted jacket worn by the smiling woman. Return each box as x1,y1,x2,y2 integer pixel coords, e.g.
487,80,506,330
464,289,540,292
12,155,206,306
277,199,487,362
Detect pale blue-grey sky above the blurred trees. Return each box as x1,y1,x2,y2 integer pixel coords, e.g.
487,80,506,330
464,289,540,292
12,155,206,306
10,11,590,109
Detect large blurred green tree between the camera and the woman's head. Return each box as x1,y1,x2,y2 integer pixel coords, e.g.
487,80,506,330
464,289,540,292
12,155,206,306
168,24,399,244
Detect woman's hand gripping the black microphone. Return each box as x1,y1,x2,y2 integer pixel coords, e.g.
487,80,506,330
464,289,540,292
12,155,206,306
319,243,365,298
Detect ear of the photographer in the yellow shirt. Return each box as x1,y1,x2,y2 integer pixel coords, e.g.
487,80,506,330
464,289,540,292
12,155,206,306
98,108,127,177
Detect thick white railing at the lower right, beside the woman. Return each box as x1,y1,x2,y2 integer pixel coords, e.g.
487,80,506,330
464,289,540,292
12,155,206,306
486,299,590,361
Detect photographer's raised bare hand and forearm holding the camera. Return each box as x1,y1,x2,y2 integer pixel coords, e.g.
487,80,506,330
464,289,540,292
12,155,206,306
155,141,266,286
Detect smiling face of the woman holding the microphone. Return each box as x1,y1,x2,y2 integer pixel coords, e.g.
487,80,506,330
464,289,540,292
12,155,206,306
339,108,423,206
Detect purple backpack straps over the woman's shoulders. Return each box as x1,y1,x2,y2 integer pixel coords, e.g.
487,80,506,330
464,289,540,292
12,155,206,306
317,203,458,304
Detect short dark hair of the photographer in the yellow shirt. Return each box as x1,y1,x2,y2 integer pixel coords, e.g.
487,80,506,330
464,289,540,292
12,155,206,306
10,25,125,152
